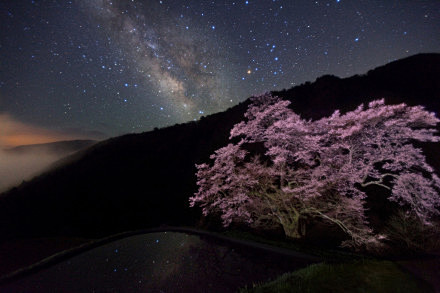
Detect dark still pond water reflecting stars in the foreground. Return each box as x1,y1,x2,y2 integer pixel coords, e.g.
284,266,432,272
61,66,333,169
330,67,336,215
0,232,307,292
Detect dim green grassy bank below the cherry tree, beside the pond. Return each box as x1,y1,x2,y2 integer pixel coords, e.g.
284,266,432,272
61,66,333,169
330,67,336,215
240,260,433,293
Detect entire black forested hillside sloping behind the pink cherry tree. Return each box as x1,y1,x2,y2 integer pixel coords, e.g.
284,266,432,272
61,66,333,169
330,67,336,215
0,54,440,240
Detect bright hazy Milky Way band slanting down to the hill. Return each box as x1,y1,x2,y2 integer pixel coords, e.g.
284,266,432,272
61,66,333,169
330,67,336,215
84,0,233,120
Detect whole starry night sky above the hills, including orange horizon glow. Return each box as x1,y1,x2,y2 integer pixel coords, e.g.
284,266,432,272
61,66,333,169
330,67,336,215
0,0,440,146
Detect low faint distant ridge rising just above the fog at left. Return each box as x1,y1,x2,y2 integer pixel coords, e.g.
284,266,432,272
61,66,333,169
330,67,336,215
5,140,96,156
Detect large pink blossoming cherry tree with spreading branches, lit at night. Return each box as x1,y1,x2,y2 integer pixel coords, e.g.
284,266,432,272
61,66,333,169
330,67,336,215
190,94,440,247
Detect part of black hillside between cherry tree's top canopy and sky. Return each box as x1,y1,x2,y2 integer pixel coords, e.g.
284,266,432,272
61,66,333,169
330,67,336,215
276,54,440,119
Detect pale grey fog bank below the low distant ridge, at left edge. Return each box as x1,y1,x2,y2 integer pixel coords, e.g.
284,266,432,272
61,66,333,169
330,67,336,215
0,150,62,192
